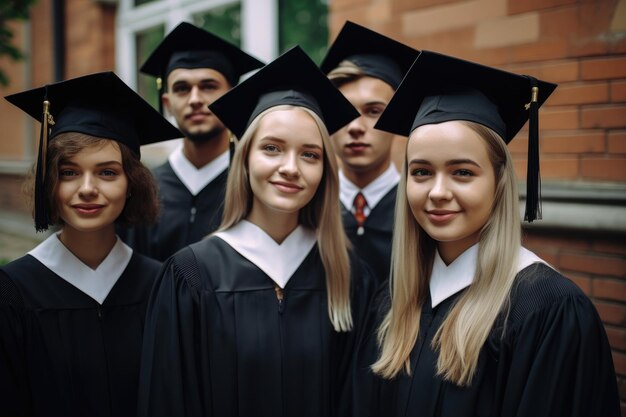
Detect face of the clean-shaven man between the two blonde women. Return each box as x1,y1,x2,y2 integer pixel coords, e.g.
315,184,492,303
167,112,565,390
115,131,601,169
332,77,394,178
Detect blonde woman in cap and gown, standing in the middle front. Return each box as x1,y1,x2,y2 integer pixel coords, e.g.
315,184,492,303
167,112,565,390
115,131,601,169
139,48,371,417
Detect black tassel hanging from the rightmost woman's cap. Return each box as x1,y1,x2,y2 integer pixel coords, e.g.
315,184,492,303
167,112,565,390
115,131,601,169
524,76,541,223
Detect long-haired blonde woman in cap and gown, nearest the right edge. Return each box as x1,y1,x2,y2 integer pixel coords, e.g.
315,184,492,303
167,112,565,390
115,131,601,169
353,51,620,417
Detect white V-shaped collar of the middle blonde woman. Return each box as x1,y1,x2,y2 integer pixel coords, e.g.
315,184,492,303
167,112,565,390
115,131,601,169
214,220,317,288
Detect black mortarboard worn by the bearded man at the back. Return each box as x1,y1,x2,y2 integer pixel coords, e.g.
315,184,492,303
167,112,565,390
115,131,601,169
140,22,263,90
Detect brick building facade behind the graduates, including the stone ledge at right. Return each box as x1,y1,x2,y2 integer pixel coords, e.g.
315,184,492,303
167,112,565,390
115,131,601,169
0,0,626,415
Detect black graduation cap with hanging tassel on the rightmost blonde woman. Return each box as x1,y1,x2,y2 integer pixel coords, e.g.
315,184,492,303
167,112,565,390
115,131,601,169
375,51,556,222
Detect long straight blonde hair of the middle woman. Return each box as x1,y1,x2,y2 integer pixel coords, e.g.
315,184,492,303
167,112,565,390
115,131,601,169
218,105,352,331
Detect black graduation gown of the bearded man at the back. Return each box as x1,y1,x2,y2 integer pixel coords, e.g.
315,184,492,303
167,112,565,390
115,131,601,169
118,161,228,261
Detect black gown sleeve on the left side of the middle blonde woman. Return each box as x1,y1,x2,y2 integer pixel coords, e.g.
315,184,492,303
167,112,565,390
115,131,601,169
138,248,211,417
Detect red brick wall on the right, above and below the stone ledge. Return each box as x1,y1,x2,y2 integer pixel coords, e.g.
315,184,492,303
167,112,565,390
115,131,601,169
329,0,626,415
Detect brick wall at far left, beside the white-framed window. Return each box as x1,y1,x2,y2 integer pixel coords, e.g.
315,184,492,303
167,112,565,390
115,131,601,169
0,0,116,218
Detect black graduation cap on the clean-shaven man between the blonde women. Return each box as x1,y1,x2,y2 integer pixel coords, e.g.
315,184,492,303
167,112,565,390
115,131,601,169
320,21,419,90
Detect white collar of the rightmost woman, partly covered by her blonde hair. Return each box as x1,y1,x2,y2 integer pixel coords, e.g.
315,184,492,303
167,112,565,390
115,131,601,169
430,244,547,308
